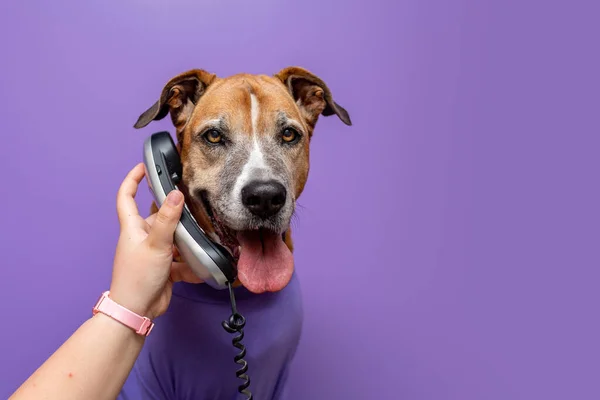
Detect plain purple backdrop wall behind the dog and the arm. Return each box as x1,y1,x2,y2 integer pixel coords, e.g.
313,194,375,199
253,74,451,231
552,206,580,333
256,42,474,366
0,0,600,400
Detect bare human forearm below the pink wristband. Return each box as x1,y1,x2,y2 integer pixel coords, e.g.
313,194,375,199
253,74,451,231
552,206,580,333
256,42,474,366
10,313,144,400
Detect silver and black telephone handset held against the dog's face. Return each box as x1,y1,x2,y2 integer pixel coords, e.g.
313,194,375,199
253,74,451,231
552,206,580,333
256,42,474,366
144,131,237,289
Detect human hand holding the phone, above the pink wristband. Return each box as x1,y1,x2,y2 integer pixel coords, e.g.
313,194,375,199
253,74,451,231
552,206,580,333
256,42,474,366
110,164,202,319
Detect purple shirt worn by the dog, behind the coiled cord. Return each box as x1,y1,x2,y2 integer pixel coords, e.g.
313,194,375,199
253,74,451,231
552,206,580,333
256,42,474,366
118,274,302,400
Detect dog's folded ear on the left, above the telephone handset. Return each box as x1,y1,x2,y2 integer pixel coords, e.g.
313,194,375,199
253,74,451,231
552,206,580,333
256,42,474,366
134,69,217,132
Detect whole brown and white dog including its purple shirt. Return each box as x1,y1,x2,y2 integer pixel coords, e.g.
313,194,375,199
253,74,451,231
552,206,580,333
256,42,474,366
119,67,352,400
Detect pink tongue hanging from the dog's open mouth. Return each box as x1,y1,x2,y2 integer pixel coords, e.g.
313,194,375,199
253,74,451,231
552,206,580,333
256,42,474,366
238,230,294,293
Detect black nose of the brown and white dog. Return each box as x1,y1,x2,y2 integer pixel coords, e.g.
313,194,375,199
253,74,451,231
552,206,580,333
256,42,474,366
242,181,286,218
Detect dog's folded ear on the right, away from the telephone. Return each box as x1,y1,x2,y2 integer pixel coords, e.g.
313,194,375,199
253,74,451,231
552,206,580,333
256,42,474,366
275,67,352,127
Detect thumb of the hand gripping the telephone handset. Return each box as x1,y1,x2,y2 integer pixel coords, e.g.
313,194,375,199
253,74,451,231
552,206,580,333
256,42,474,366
146,190,183,250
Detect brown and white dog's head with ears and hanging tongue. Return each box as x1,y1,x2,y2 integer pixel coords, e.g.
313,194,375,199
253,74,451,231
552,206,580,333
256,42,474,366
135,67,351,293
